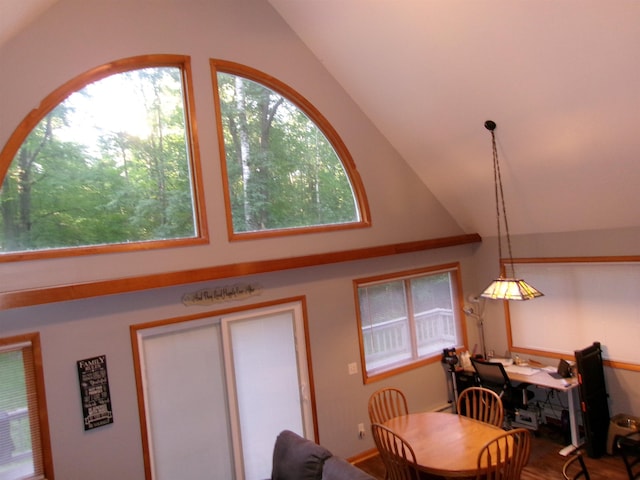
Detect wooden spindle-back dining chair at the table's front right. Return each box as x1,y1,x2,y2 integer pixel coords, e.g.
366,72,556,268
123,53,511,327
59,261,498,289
476,428,531,480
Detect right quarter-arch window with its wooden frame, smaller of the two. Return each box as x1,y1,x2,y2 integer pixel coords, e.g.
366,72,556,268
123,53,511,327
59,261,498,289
211,60,369,239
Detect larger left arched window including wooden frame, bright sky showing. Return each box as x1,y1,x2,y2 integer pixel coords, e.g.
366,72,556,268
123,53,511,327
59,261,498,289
0,55,206,260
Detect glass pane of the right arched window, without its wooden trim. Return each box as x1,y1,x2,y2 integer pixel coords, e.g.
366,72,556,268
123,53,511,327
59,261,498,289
217,73,360,233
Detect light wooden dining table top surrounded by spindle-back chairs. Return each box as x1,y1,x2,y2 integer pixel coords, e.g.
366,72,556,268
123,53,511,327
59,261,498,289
384,412,504,477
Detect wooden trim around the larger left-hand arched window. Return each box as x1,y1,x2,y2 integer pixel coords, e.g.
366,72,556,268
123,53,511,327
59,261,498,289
0,54,209,262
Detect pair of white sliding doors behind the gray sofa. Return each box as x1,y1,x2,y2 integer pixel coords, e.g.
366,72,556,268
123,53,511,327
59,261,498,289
137,301,314,480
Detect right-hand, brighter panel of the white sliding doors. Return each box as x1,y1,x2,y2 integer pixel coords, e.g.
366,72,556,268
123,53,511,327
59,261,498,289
221,302,315,480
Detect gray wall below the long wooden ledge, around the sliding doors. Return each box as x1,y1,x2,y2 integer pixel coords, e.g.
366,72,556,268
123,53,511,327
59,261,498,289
0,247,471,480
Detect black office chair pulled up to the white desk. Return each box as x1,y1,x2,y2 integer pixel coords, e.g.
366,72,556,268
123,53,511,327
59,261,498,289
471,358,534,419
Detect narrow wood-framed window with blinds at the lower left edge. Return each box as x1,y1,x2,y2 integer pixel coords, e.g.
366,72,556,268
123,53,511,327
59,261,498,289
0,334,53,480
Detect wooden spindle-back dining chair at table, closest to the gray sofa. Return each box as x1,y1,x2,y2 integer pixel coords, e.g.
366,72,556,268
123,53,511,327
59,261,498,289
371,423,421,480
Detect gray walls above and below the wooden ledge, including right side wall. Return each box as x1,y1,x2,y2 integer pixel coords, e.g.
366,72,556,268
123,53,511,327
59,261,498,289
0,0,640,480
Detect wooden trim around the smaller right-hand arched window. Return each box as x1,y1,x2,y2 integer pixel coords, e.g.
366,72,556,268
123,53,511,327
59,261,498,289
210,59,371,241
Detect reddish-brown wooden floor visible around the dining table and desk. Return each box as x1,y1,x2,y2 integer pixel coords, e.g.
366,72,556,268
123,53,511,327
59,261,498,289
357,426,628,480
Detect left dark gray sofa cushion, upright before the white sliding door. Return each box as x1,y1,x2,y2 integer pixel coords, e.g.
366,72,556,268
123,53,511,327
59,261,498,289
271,430,331,480
